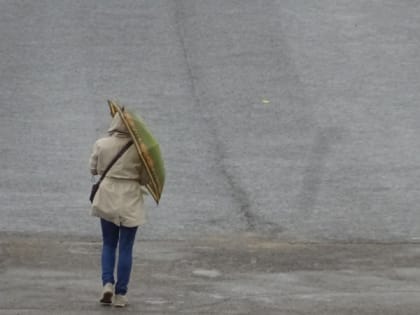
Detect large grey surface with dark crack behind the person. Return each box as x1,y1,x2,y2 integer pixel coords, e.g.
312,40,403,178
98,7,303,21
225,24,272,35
0,0,420,241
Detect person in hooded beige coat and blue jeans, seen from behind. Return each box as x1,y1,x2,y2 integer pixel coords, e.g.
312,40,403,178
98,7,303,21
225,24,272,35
90,113,147,307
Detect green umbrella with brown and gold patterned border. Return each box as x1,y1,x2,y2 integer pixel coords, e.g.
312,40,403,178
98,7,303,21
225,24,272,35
108,100,165,204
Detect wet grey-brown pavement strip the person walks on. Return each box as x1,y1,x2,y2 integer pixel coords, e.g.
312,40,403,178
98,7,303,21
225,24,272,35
0,233,420,315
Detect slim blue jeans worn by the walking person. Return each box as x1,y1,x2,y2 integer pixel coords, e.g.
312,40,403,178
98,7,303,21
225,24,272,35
101,219,137,295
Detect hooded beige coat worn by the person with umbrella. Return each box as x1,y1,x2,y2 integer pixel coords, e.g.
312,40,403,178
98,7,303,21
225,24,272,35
90,114,146,227
